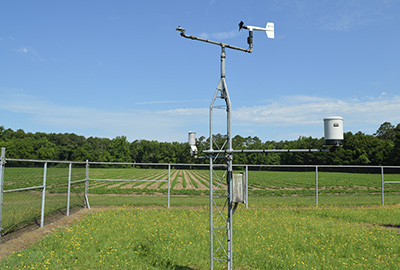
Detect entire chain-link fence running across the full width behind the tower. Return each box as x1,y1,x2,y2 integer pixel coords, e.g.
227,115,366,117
0,149,400,240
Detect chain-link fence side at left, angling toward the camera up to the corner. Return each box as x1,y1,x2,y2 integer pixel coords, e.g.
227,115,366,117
0,151,87,242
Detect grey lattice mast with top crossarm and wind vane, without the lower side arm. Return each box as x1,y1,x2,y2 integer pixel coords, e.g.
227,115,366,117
176,22,274,270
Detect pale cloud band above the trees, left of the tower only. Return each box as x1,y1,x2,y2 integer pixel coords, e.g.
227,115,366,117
0,89,208,141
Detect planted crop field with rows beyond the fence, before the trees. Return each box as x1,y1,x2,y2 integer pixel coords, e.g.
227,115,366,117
4,167,400,196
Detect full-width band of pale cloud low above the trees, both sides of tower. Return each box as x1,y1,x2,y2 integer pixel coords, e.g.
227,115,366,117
0,89,400,141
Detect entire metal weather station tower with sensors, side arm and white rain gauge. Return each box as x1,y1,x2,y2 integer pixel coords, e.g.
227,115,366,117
176,21,343,270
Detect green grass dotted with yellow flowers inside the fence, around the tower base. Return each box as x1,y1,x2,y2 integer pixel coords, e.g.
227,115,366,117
0,206,400,269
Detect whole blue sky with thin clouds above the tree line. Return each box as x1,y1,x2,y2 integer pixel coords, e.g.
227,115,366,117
0,0,400,142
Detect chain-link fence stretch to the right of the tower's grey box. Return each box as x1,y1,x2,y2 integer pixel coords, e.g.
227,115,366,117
242,165,400,206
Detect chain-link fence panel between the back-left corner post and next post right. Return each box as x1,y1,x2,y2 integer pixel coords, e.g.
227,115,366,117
88,162,170,207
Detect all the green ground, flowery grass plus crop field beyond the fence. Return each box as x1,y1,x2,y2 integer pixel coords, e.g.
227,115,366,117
0,166,400,269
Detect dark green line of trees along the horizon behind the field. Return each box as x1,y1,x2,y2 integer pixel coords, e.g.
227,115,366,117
0,122,400,165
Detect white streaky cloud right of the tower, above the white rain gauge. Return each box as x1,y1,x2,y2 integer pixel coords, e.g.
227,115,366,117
233,93,400,126
